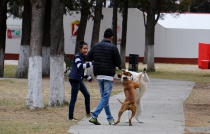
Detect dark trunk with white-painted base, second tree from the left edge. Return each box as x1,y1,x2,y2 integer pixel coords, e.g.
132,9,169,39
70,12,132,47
15,0,31,78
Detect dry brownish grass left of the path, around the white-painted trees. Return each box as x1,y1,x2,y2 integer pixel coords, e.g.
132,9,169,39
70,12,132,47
0,78,123,134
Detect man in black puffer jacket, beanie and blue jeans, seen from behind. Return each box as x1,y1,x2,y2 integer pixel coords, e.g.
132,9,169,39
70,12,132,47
87,28,121,125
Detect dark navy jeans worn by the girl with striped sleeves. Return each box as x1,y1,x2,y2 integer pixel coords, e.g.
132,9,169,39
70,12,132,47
69,79,90,119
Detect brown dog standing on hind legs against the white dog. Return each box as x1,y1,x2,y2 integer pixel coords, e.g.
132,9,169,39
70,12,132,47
115,71,142,126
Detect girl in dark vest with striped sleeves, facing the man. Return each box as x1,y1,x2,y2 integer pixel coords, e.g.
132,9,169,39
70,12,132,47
68,41,93,121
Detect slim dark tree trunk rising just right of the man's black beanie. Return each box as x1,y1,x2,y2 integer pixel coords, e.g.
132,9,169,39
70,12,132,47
112,0,118,45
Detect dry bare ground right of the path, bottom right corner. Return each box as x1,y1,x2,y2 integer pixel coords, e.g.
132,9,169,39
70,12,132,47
184,83,210,134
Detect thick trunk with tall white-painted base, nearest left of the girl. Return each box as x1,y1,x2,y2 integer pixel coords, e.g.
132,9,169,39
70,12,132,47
49,0,65,106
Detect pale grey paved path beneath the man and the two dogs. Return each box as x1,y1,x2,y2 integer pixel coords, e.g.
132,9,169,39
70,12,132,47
68,79,195,134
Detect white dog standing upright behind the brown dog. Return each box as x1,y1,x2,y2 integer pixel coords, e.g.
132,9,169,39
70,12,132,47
118,68,150,123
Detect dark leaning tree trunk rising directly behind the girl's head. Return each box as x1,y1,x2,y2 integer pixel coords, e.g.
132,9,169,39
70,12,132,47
74,0,90,54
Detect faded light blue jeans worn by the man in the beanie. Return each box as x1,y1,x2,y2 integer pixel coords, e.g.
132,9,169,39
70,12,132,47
92,80,113,122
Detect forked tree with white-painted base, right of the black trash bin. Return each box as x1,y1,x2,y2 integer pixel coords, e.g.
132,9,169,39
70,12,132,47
136,0,189,71
